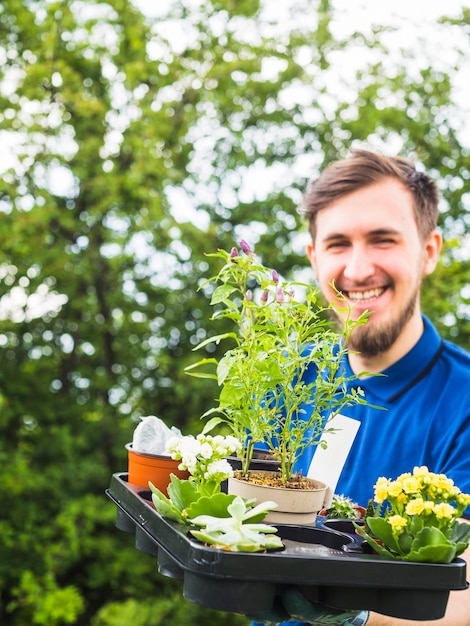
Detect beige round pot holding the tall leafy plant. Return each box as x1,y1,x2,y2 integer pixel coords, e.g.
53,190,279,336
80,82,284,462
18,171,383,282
228,472,328,525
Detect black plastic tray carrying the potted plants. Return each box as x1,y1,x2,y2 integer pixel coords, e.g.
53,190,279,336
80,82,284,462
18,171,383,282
106,473,467,620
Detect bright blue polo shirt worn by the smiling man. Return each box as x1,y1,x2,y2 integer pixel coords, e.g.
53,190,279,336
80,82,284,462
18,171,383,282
296,317,470,517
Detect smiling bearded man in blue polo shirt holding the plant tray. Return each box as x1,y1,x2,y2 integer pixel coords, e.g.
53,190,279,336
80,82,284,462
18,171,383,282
253,150,470,626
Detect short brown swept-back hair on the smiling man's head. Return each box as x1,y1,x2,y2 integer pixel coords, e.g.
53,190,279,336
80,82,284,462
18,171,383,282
302,150,439,240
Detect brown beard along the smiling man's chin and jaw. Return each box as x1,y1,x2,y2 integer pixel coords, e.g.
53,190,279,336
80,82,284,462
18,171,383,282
348,281,421,358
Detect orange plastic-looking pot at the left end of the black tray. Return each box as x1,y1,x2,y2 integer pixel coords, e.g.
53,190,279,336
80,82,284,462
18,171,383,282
126,443,189,495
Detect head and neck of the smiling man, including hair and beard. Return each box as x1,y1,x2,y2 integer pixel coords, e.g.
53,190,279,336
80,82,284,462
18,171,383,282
305,156,441,373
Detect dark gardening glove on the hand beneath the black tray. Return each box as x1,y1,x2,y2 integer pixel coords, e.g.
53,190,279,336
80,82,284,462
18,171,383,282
251,585,369,626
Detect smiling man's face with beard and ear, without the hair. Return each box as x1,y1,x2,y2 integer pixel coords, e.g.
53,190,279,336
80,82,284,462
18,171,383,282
307,178,441,357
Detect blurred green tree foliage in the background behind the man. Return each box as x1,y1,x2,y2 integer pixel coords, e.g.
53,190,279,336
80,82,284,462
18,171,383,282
0,0,470,626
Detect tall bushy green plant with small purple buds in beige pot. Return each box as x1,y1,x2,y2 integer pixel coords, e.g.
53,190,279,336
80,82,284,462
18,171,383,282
186,241,367,484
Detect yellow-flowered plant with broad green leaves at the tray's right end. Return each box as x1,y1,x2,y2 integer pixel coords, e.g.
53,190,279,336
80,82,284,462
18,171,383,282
355,466,470,563
